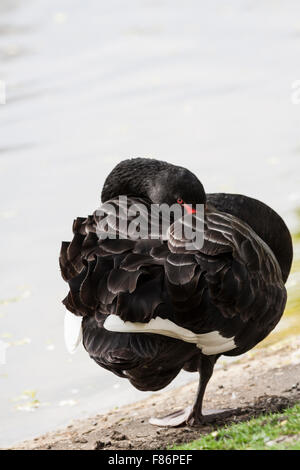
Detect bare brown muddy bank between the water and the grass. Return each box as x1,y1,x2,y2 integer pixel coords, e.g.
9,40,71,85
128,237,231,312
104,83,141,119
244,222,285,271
6,337,300,450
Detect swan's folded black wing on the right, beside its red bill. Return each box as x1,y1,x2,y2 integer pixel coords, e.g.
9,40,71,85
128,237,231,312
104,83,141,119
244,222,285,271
168,207,286,330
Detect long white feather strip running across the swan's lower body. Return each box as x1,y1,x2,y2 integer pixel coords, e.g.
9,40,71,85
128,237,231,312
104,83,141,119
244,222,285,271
103,315,236,356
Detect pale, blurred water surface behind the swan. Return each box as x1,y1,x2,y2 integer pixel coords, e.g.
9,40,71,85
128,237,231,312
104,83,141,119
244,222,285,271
0,0,300,446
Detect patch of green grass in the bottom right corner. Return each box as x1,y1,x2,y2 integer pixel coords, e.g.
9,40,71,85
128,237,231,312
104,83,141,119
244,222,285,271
172,404,300,450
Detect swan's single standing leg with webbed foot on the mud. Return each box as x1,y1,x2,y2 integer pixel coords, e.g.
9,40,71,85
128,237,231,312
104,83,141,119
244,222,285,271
149,354,229,427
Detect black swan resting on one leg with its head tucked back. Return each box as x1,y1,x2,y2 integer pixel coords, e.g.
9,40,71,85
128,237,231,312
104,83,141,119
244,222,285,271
60,158,293,426
